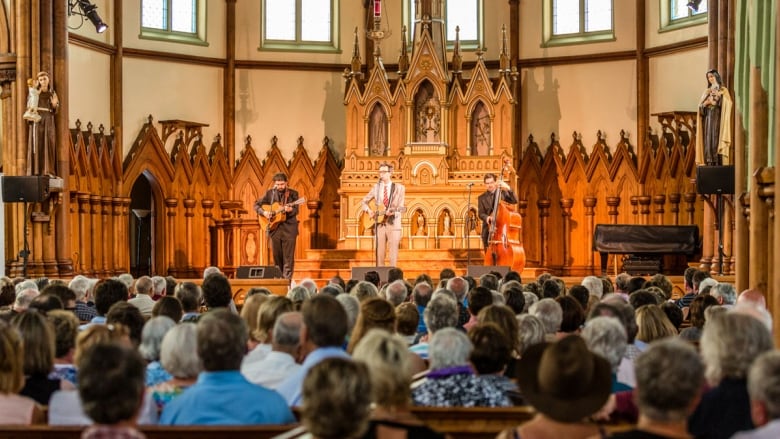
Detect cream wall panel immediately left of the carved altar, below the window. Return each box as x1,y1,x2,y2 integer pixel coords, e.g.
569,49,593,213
236,70,346,159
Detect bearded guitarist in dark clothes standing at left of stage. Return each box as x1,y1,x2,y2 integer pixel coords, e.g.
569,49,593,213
255,172,300,279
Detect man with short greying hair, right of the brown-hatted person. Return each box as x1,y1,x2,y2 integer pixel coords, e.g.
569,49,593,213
612,338,704,439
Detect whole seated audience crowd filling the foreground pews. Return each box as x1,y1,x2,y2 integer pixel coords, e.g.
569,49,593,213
0,267,780,439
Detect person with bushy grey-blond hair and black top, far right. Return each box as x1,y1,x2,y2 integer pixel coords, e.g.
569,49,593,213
688,312,773,438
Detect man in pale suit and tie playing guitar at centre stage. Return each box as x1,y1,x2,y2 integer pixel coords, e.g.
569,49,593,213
361,163,406,267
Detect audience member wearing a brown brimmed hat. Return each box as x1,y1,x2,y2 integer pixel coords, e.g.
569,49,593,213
498,336,611,439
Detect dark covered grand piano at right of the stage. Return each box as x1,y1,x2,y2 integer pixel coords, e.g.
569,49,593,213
593,224,700,275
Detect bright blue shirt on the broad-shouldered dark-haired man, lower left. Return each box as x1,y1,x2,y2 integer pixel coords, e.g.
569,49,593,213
160,370,295,425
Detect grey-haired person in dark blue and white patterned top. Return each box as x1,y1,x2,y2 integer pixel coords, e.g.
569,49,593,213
412,328,512,407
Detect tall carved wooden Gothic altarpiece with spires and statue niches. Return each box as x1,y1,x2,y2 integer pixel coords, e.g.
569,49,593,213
339,7,516,254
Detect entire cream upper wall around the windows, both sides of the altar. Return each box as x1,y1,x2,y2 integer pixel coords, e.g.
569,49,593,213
70,0,706,163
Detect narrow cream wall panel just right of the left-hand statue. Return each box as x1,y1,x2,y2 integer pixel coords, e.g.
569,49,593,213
68,45,111,133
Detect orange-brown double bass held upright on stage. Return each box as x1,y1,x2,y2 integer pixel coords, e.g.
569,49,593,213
485,160,525,273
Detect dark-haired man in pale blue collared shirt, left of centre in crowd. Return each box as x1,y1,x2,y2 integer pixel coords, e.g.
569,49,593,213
276,294,349,406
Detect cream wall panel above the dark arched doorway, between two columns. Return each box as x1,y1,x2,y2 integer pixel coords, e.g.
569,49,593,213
122,58,224,150
